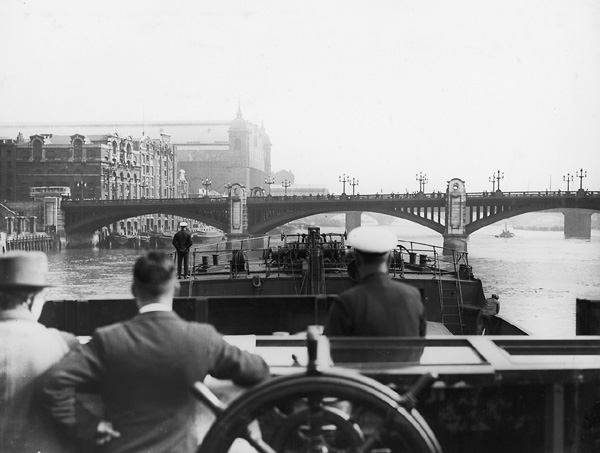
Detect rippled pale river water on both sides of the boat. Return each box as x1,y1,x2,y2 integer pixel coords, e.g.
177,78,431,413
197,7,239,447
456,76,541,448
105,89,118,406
47,220,600,338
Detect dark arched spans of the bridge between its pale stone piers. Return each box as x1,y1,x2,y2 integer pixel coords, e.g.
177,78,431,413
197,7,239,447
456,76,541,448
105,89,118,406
62,190,600,235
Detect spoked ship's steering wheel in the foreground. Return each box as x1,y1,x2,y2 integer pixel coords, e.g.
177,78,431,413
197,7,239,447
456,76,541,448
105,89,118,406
194,328,441,453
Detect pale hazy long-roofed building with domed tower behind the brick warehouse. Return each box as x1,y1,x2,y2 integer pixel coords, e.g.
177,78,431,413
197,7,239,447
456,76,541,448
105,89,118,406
0,108,271,197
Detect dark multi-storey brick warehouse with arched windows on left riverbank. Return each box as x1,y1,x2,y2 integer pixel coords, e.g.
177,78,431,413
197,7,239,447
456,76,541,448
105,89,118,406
0,133,176,233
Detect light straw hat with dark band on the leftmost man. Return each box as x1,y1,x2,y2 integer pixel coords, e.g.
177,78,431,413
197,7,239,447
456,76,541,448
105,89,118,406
0,252,49,289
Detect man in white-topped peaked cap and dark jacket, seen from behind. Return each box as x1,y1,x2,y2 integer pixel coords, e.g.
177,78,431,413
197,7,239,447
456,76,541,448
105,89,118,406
324,227,427,337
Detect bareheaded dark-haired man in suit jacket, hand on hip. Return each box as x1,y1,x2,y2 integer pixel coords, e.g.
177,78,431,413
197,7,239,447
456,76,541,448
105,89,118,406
44,252,269,453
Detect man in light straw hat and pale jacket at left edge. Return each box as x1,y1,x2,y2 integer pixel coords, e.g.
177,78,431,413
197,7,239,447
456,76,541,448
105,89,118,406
0,252,79,453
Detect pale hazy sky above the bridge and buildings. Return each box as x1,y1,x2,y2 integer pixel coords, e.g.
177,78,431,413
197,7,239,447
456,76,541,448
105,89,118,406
0,0,600,193
